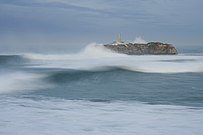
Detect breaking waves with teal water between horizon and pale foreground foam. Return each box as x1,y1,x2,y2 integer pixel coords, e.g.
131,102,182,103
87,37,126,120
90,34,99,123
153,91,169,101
0,44,203,106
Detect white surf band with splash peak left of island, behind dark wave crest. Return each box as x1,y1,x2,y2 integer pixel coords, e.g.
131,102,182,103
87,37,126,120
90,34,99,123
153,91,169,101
21,44,203,73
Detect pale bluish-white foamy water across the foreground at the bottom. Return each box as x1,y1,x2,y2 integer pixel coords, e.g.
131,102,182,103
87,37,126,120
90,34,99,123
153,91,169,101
0,98,203,135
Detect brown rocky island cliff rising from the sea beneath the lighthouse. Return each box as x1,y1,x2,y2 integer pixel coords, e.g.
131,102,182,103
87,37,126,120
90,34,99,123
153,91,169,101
104,42,178,55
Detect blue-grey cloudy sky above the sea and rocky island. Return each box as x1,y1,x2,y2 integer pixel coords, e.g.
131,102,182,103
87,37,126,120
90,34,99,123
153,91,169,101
0,0,203,53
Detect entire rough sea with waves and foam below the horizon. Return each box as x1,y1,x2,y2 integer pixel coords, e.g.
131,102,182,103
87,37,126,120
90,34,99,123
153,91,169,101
0,45,203,135
